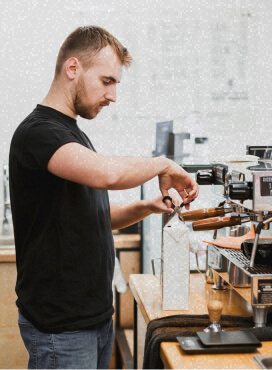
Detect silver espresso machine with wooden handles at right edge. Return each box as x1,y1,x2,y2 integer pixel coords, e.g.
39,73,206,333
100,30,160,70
185,147,272,327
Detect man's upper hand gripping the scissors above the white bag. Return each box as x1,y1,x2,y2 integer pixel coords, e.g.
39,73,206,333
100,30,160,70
159,160,199,209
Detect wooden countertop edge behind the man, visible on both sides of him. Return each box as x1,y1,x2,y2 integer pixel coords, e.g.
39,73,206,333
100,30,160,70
0,234,141,262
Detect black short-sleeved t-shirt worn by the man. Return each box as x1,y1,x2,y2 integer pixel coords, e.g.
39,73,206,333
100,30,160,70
9,105,114,333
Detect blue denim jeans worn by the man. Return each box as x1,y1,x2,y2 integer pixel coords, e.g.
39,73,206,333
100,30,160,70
18,311,114,369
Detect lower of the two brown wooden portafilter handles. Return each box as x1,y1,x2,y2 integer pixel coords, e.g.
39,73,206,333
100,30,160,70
192,216,241,231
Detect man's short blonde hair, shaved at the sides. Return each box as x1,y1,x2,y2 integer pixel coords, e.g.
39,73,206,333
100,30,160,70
55,26,132,78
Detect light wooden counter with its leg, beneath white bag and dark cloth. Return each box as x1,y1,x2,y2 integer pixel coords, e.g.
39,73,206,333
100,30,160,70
130,274,272,369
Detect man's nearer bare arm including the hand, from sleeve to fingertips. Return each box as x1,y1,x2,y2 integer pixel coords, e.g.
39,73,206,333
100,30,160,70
47,143,198,207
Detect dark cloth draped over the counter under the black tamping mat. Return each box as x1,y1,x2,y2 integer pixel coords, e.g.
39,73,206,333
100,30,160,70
143,313,272,369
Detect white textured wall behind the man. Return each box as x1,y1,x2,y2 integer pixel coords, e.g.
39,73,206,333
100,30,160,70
0,0,272,224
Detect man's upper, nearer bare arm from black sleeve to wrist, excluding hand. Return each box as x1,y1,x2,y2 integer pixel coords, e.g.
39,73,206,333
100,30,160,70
48,143,170,190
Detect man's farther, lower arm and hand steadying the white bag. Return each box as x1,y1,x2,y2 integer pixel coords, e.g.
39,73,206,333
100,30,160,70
110,195,173,230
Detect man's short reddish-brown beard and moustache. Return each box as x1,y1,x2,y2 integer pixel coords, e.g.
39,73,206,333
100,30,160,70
74,78,105,120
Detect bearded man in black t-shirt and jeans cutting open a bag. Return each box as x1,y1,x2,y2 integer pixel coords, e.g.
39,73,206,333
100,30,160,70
9,27,198,369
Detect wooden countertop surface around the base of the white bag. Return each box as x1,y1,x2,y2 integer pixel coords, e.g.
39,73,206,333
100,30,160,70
129,273,252,324
